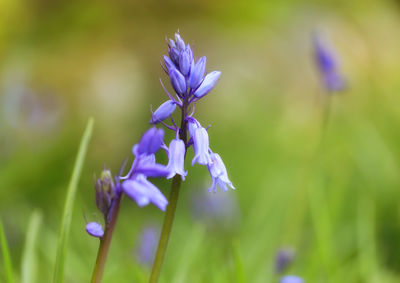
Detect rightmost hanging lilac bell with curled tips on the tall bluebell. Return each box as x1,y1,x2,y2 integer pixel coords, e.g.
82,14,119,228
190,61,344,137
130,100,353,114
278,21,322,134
207,152,235,192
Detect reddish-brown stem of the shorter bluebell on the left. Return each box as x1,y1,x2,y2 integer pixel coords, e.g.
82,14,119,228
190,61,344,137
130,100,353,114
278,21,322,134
91,194,122,283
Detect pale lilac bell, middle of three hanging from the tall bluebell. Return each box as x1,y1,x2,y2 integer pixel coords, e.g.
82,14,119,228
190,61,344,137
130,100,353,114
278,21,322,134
192,126,211,166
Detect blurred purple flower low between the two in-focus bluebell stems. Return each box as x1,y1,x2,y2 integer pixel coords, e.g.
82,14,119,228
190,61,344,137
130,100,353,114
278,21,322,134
136,226,159,266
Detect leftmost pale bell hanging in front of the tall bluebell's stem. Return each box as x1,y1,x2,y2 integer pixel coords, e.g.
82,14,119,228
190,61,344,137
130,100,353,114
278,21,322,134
167,139,187,180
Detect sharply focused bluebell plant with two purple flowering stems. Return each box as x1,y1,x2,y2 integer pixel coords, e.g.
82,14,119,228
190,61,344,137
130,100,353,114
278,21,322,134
86,32,235,282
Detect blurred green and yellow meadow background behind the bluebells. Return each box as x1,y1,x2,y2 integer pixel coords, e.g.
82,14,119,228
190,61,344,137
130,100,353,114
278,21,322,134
0,0,400,282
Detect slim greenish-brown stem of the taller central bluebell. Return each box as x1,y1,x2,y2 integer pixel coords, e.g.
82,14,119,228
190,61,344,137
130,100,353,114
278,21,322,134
149,99,189,283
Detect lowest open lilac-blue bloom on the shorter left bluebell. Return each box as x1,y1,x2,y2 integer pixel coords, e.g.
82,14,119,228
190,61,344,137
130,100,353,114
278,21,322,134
122,174,168,211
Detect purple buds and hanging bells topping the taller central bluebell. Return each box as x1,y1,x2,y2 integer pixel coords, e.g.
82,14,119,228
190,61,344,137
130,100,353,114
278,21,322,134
150,33,234,192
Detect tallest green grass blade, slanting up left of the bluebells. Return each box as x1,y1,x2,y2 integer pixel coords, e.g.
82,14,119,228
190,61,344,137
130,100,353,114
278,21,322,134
53,118,94,283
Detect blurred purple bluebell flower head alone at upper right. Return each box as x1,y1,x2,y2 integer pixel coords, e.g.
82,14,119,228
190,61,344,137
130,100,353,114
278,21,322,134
313,34,346,92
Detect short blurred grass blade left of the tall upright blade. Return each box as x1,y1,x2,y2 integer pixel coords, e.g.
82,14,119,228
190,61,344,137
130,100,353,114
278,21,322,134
21,211,42,283
